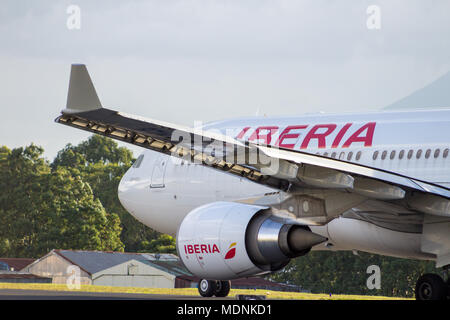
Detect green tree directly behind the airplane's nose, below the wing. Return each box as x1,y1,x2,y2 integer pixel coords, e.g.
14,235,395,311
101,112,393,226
51,135,174,252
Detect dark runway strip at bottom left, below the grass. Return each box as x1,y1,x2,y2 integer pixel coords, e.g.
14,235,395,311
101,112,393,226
0,289,232,300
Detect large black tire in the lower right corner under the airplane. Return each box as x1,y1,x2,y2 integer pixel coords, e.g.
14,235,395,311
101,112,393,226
416,273,447,300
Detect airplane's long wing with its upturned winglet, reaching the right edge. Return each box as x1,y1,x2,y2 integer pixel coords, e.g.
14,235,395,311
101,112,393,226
55,65,450,217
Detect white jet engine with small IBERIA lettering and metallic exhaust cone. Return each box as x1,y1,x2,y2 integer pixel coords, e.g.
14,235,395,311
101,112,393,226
177,202,326,280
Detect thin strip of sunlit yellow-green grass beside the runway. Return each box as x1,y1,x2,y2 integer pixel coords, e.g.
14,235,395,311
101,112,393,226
0,283,410,300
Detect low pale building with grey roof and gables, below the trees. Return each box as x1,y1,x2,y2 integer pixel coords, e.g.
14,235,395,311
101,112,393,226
23,250,190,288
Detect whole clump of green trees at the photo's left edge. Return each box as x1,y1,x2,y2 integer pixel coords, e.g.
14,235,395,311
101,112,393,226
0,144,123,257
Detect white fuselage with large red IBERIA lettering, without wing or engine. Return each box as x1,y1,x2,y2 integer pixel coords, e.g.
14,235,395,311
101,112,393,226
119,110,450,259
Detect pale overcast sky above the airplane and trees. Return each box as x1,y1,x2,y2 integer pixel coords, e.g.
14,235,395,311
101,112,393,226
0,0,450,160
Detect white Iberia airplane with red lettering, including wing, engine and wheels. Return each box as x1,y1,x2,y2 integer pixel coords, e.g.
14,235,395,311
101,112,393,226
55,64,450,300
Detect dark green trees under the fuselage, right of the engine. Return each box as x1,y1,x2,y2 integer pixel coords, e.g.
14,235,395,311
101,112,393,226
270,251,435,297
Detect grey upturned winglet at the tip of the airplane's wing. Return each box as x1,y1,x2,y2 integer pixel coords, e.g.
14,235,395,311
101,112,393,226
62,64,102,113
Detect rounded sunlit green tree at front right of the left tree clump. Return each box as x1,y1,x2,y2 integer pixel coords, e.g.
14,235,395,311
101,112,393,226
37,168,124,255
